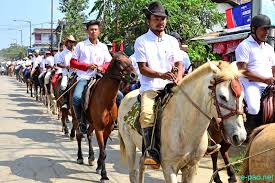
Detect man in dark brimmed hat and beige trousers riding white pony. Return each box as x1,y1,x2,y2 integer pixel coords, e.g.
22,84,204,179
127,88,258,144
134,2,182,168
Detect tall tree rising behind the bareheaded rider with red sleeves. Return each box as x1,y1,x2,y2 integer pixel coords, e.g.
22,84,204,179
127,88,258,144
59,0,89,41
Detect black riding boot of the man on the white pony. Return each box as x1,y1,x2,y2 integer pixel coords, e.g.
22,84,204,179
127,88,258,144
142,127,160,169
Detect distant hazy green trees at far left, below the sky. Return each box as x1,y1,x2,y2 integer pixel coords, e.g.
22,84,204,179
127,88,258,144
0,44,27,60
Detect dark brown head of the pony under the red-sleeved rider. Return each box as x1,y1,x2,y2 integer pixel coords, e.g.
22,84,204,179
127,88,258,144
106,52,137,82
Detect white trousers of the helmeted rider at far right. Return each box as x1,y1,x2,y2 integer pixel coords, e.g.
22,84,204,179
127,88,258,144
244,79,267,115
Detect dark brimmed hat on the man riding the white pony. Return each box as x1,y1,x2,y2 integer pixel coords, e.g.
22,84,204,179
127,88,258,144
143,2,169,17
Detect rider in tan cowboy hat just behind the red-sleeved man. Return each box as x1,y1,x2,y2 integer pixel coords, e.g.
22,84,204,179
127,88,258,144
57,35,76,108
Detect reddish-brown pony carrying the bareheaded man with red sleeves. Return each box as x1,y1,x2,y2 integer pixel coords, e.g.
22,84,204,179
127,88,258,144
72,53,135,181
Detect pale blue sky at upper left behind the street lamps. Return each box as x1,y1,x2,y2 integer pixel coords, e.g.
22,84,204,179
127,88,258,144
0,0,94,49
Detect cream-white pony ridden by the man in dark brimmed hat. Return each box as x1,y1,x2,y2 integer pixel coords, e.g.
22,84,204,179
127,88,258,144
118,61,246,183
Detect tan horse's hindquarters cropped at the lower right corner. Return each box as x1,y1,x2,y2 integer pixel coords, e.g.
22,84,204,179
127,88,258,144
240,123,275,183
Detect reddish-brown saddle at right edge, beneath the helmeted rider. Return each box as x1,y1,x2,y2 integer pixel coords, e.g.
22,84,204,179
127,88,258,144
261,84,275,124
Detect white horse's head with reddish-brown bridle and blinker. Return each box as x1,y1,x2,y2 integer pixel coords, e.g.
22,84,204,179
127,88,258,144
209,62,247,146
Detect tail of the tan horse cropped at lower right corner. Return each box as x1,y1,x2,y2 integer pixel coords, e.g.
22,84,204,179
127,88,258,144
239,124,268,176
